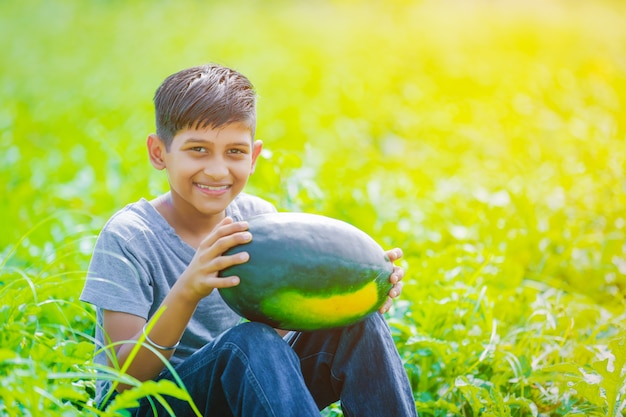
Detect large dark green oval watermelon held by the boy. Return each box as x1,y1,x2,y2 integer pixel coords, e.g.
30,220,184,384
219,213,393,331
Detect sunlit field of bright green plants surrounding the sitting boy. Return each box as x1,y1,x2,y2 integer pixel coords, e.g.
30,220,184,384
0,0,626,417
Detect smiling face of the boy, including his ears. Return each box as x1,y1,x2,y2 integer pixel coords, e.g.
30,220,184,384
156,123,262,219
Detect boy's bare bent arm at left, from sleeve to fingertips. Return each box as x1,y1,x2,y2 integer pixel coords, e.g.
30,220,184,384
103,218,251,391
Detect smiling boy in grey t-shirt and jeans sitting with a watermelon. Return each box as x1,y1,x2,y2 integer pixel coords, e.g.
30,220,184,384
81,65,417,417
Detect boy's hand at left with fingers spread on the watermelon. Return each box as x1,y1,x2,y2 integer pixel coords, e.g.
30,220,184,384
176,217,252,302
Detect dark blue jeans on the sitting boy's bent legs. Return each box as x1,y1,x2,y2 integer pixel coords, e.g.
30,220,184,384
125,313,417,417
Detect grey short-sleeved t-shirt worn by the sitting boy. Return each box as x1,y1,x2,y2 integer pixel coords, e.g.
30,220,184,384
81,193,276,395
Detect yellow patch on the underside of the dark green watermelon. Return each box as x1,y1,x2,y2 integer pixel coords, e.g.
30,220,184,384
261,281,379,328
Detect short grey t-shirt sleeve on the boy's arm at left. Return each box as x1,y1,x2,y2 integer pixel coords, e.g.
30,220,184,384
81,224,154,319
